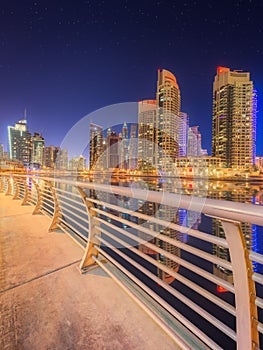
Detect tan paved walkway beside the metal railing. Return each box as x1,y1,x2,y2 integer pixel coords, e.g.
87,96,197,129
0,194,180,350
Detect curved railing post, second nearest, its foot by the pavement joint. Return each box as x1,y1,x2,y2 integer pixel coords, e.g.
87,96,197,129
78,187,100,272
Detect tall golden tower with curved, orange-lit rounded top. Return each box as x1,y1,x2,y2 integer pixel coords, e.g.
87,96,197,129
156,69,181,173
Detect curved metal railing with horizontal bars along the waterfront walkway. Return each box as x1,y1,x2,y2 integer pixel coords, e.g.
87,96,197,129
0,174,263,350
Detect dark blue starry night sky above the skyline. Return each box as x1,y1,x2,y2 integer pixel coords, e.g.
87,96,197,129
0,0,263,155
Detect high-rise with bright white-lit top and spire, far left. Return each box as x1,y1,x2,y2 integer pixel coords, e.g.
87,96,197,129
7,119,32,166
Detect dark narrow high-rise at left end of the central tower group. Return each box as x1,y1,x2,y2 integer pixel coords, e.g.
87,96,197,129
89,123,103,170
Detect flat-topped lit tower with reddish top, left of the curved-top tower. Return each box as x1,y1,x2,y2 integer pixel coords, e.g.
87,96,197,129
138,100,158,169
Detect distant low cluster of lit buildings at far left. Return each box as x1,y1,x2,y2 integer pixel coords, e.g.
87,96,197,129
0,117,86,171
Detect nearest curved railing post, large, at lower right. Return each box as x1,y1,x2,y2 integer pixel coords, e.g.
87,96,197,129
221,219,259,350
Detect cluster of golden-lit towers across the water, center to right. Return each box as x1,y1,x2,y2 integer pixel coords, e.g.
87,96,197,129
90,67,259,176
